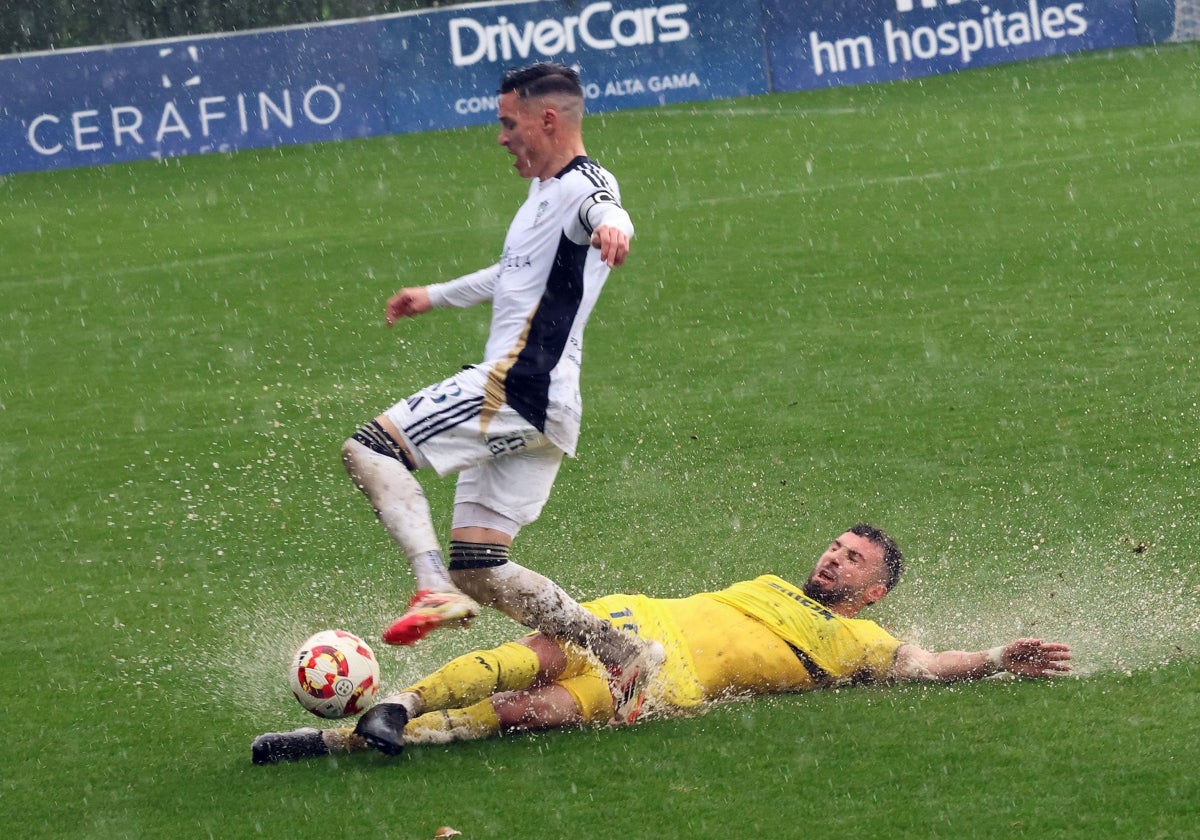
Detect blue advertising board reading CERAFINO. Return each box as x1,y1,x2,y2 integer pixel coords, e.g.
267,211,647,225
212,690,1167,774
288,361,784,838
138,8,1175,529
0,24,388,172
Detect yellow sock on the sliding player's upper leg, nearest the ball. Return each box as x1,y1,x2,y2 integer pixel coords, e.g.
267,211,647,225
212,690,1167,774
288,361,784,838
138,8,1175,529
404,642,539,714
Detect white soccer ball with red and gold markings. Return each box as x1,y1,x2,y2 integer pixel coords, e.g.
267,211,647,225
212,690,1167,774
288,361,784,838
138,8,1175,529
288,630,379,718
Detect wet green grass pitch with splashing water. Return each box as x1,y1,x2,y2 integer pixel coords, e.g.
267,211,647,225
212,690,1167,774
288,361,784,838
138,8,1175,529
0,44,1200,840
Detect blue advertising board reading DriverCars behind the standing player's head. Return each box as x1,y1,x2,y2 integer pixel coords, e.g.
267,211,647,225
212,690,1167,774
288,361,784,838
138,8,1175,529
379,0,767,132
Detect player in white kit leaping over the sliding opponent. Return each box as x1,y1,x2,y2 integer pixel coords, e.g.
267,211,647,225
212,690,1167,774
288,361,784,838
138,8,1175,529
342,62,664,751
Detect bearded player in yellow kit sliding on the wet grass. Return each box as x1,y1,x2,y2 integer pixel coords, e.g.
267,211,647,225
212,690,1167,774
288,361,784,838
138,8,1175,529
252,524,1070,764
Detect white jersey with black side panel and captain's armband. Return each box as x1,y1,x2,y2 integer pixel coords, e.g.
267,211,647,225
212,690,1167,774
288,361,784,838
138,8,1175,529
428,156,634,456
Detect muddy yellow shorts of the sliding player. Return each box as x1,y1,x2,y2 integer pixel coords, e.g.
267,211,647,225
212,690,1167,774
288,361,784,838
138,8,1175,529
557,595,704,724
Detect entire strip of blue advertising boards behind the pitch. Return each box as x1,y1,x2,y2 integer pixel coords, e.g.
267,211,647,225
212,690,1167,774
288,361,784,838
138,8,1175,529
0,0,1176,173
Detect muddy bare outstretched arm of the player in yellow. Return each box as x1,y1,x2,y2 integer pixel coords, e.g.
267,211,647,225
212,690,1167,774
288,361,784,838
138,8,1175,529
890,638,1070,683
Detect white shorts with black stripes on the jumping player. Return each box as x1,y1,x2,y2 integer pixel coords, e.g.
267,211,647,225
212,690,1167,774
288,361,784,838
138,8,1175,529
384,365,563,524
